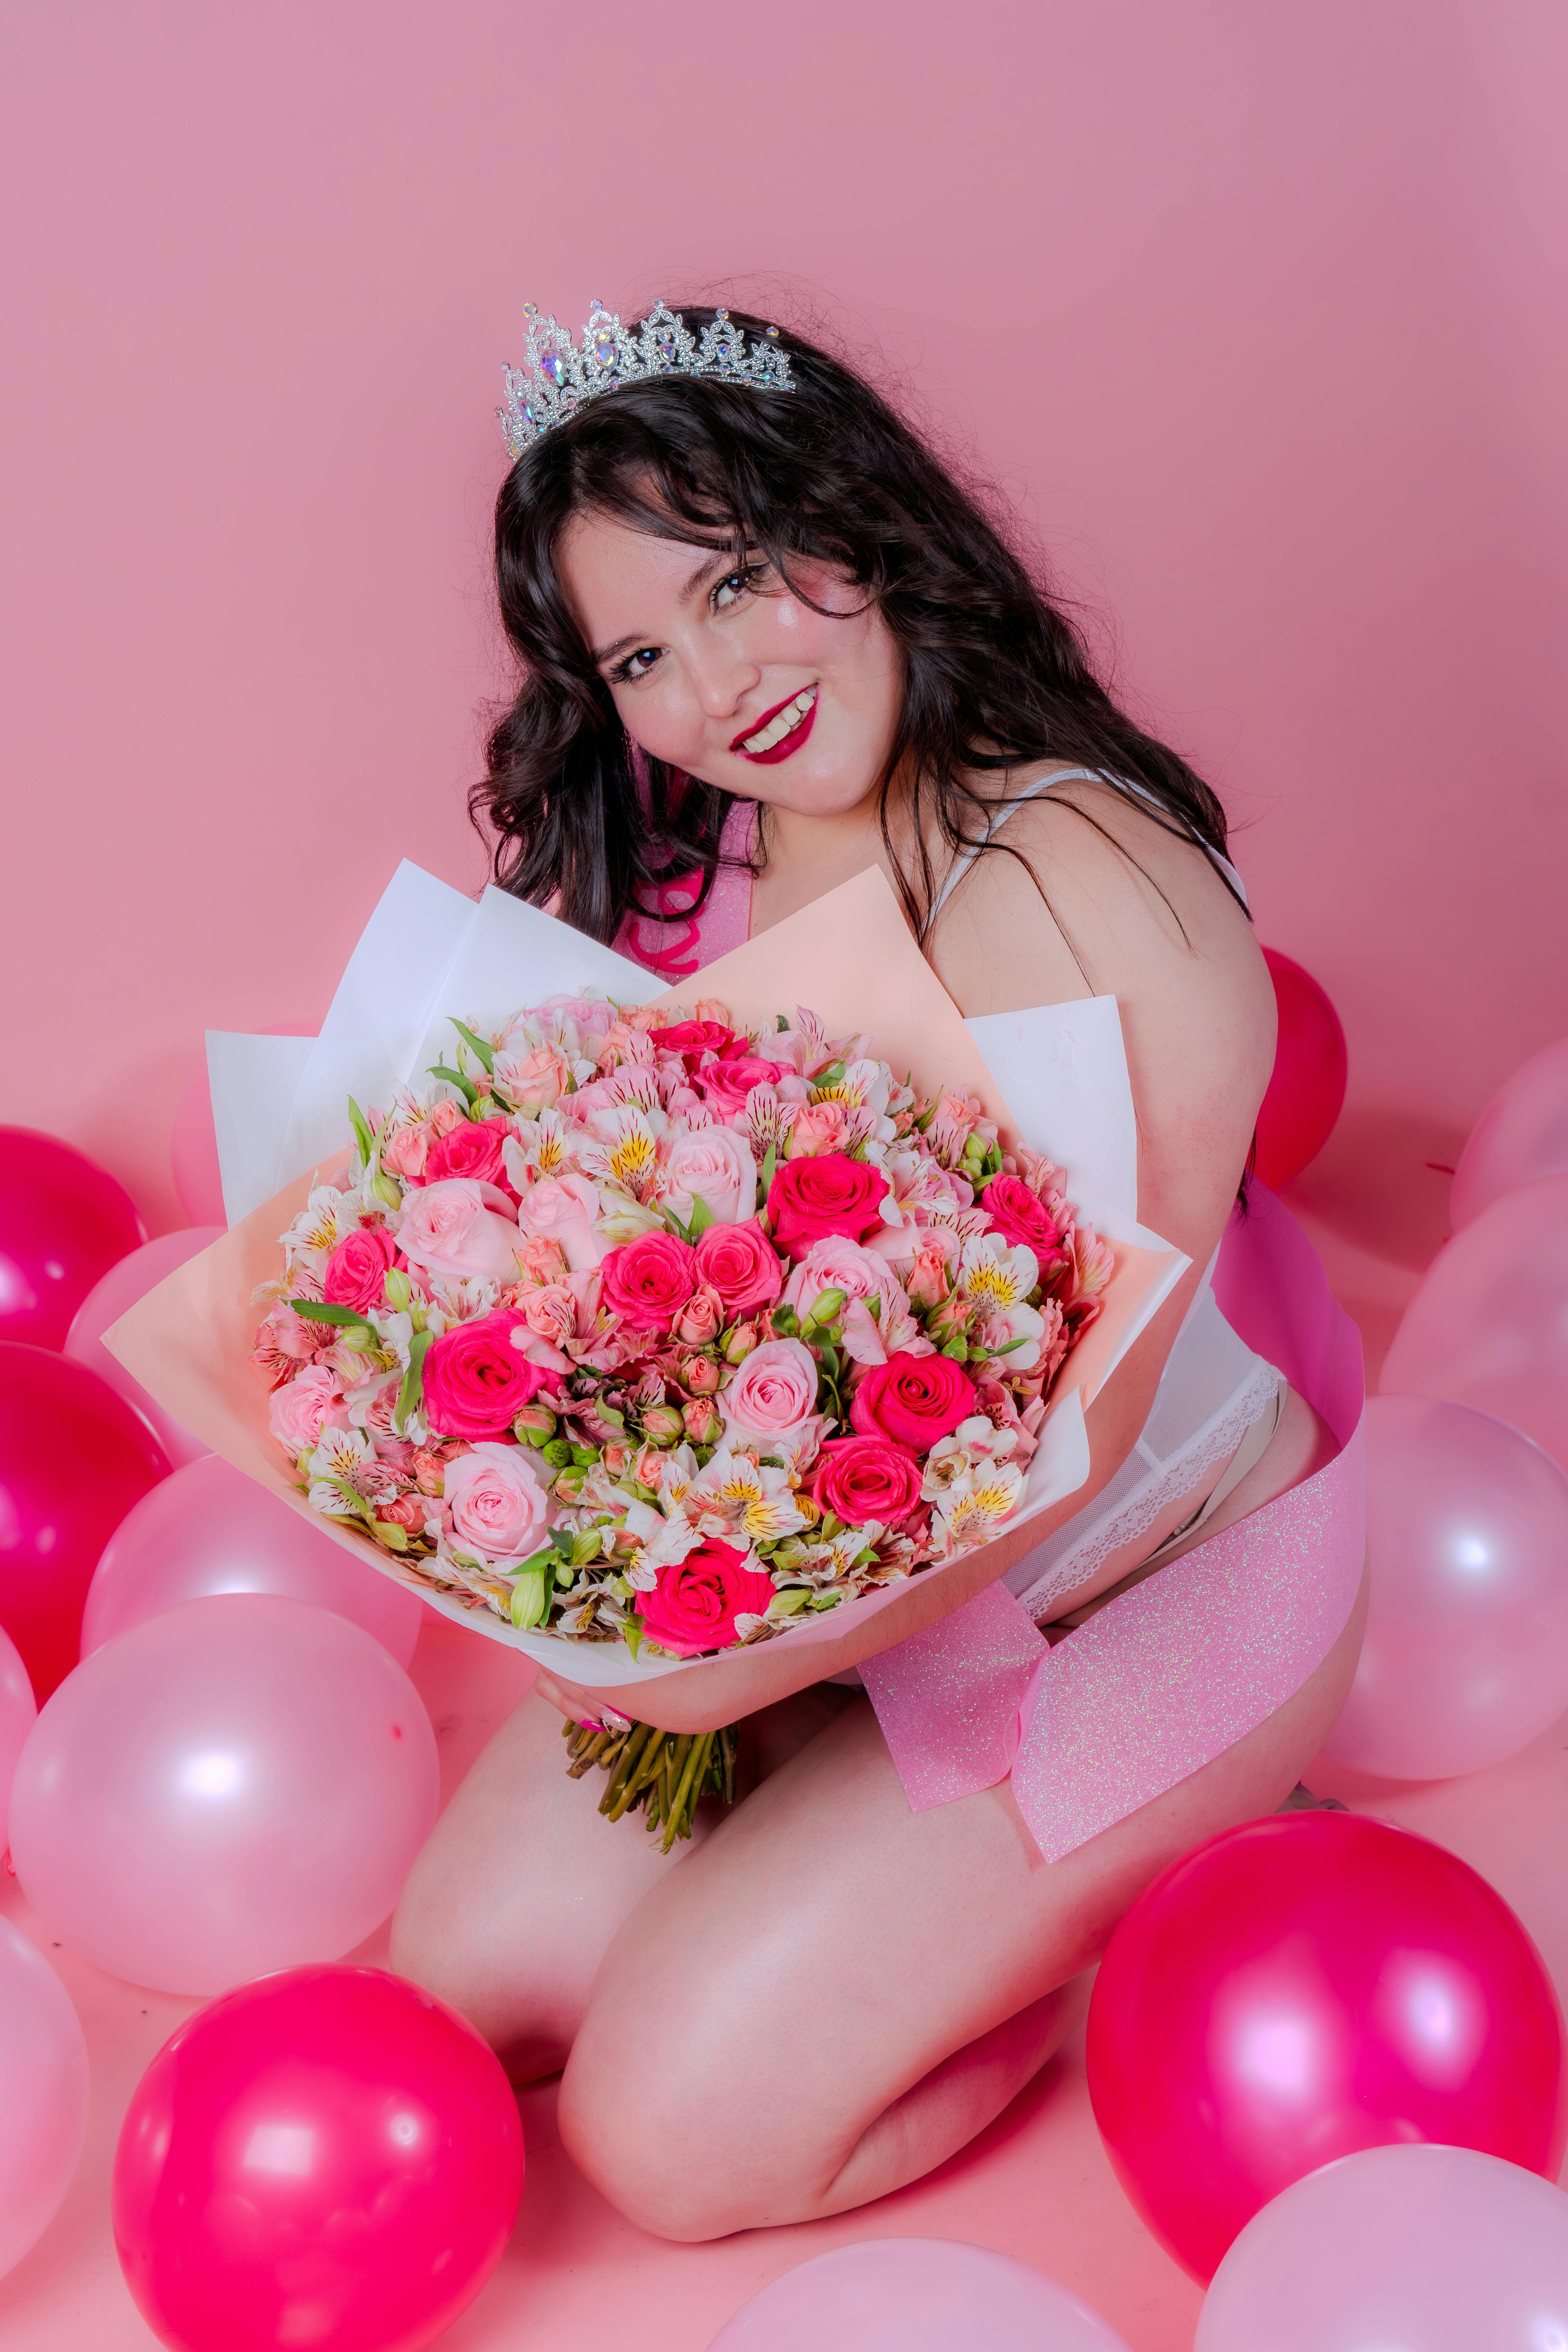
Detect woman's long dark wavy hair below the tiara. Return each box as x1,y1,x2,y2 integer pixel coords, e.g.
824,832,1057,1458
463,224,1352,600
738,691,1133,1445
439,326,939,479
470,308,1225,941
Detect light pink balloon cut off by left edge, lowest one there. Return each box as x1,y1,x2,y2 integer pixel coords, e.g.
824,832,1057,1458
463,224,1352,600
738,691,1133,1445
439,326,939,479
0,1919,87,2272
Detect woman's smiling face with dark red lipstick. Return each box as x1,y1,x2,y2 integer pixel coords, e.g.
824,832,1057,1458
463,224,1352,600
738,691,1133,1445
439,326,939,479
557,515,903,816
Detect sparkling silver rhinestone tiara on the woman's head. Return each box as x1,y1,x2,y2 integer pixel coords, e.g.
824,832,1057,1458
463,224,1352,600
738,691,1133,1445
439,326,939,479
496,301,795,459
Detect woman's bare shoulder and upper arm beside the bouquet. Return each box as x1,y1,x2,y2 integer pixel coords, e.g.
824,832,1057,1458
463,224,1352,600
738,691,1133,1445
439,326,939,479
931,779,1274,1256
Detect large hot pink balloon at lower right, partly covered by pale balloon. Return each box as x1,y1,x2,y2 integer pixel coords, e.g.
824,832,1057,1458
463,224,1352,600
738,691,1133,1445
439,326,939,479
1089,1813,1568,2279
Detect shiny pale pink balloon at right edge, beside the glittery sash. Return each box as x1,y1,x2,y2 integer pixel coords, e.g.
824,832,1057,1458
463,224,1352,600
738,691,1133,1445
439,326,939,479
1326,1397,1568,1780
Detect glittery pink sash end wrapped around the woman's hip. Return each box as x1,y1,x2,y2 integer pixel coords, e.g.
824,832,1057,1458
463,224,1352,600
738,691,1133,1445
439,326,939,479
860,1183,1366,1863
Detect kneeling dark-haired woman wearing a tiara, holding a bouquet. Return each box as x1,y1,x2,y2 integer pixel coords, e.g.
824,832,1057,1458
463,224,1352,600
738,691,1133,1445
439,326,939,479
392,310,1361,2239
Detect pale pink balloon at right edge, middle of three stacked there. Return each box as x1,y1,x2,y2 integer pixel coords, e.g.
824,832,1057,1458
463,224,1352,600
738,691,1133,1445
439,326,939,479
1377,1176,1568,1470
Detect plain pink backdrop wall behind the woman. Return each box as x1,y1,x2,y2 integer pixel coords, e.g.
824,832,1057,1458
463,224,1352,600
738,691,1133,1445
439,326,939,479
0,0,1568,1310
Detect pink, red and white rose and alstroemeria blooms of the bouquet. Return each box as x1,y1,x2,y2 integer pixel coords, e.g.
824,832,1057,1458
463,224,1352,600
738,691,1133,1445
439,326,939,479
254,997,1112,1658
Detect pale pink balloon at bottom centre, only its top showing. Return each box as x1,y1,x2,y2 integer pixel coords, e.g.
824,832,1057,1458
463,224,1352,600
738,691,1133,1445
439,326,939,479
708,2237,1126,2352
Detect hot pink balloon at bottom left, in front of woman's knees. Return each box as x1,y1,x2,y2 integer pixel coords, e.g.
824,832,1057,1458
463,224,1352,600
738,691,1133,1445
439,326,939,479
113,1969,526,2352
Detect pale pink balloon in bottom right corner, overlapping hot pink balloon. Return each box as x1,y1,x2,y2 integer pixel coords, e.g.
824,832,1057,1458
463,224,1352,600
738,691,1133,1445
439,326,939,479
1192,2154,1568,2352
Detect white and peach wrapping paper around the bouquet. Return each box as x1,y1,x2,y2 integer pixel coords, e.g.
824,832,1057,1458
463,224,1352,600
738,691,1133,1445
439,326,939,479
106,866,1189,1731
